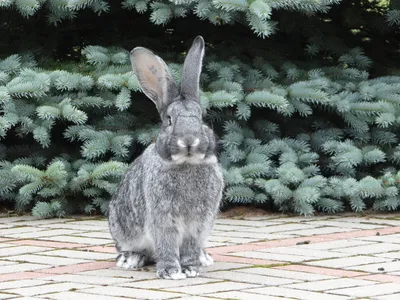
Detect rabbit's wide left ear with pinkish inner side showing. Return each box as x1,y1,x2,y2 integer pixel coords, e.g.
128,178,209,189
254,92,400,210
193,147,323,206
130,47,178,111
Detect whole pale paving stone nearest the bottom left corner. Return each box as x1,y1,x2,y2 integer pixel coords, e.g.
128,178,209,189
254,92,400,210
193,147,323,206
6,282,92,296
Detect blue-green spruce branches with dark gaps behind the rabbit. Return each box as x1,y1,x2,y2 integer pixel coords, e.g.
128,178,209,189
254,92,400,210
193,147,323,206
0,0,400,217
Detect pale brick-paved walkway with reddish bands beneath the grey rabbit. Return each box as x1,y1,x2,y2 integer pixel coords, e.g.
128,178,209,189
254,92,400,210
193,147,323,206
0,215,400,300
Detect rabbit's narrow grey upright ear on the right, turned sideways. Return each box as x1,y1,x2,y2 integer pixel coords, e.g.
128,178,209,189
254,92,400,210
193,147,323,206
181,36,204,101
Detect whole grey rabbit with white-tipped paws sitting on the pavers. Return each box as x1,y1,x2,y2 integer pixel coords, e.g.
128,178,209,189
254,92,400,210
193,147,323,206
108,36,224,279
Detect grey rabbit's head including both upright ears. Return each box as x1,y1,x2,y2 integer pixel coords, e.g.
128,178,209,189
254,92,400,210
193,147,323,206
131,36,215,163
